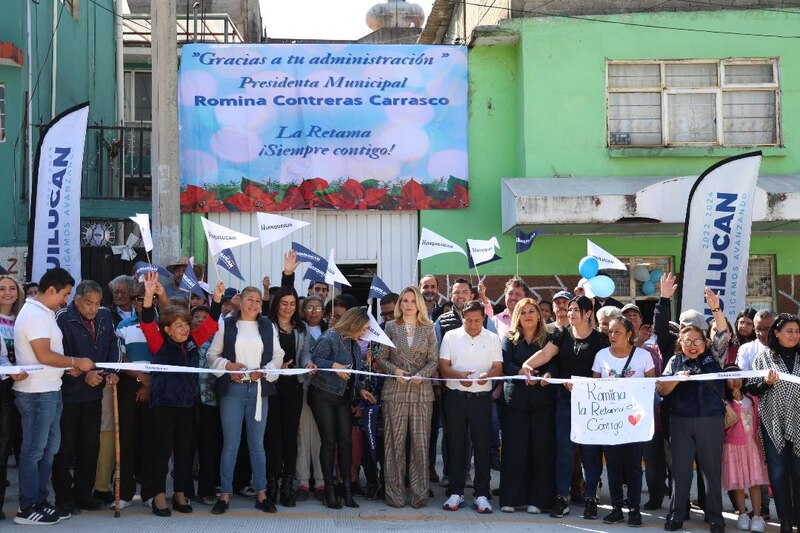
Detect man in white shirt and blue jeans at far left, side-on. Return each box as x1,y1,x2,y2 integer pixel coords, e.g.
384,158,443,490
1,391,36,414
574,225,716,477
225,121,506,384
14,268,94,525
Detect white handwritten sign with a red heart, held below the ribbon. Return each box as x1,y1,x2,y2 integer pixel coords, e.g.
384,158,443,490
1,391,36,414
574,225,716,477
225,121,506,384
570,378,656,445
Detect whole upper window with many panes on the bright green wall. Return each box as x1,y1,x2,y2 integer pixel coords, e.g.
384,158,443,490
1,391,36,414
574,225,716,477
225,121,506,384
606,58,781,148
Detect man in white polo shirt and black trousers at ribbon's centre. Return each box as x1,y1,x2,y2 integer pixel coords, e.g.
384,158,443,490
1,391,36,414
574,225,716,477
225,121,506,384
439,300,503,513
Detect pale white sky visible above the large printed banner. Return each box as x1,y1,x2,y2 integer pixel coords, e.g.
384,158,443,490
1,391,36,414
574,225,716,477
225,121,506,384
259,0,433,40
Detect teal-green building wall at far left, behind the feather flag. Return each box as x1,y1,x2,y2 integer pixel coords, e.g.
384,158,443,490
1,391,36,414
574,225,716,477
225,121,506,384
0,0,116,247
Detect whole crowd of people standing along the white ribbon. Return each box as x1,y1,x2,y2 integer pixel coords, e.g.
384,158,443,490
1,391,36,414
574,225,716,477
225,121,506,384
0,251,800,532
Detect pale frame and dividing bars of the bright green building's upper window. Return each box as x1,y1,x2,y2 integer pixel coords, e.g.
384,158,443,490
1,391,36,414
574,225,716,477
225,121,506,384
605,57,783,149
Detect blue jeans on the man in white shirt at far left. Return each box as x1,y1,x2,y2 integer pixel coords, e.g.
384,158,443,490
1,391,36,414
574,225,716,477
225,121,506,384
14,390,62,509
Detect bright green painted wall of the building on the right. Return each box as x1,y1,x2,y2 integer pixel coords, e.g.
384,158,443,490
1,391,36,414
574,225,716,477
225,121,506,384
420,10,800,275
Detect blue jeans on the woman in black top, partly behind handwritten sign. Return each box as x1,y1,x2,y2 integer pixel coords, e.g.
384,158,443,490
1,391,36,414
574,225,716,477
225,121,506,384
556,387,603,498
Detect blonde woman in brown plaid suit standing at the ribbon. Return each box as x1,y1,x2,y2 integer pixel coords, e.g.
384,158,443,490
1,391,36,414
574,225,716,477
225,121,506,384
378,287,439,508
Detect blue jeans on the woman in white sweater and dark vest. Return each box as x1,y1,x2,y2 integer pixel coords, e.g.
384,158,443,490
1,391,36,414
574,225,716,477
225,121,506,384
219,382,267,494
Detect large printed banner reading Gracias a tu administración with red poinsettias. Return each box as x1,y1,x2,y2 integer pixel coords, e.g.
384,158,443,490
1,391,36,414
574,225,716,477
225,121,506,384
178,44,468,213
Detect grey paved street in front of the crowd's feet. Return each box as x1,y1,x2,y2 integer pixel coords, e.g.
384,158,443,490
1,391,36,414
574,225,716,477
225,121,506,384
0,465,777,533
